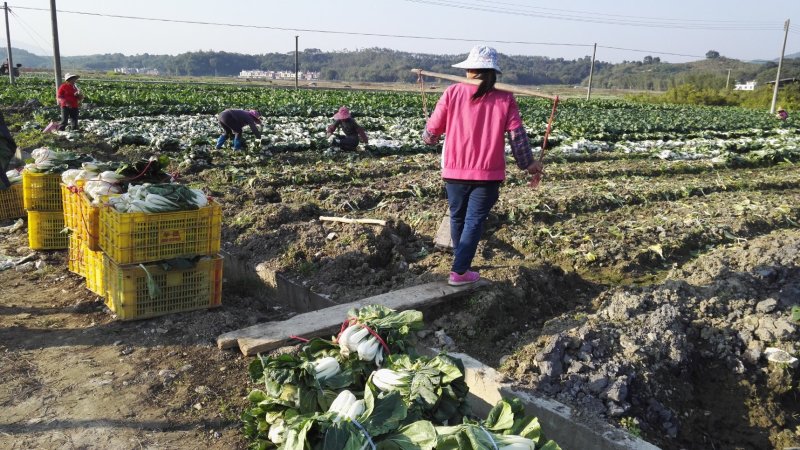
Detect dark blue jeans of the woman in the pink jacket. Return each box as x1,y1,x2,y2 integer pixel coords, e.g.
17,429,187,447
445,182,500,273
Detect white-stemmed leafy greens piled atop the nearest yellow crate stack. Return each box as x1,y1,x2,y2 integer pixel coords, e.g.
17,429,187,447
108,183,208,213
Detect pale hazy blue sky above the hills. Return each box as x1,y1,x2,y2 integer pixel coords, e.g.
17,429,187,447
9,0,800,62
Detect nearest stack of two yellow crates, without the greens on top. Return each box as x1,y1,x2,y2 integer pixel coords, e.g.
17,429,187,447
101,201,222,320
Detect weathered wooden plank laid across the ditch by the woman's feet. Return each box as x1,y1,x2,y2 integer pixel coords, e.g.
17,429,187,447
217,280,489,356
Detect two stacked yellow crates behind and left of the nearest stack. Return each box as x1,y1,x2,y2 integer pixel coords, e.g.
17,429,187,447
22,170,69,250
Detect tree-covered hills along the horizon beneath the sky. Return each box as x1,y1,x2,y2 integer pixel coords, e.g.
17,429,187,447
6,48,800,90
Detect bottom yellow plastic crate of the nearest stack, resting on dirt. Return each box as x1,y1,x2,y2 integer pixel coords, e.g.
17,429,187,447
103,255,222,320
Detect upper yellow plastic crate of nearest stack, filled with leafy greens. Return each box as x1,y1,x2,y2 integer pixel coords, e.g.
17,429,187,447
100,202,222,264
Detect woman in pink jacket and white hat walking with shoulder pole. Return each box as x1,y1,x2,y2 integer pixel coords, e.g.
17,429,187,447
422,45,542,286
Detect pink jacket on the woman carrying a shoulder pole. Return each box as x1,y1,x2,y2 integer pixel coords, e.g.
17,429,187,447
426,83,522,181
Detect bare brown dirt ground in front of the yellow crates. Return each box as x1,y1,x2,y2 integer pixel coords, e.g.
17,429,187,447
0,231,275,449
